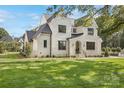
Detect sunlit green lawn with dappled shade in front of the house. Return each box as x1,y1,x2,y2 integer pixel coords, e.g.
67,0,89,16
0,53,124,88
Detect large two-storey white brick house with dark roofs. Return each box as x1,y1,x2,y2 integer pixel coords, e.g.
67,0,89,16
24,15,102,57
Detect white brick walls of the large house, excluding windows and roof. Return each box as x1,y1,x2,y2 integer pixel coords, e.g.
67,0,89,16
25,16,102,57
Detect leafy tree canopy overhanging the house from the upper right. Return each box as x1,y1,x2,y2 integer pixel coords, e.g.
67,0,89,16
47,5,124,35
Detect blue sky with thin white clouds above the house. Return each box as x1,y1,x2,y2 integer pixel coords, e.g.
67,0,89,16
0,5,101,37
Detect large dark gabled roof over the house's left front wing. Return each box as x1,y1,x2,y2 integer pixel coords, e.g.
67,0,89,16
33,23,52,38
